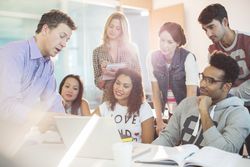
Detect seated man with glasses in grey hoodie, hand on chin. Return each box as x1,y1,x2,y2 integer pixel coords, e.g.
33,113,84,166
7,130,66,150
153,53,250,153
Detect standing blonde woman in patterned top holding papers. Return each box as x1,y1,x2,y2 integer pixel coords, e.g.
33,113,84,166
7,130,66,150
93,12,140,101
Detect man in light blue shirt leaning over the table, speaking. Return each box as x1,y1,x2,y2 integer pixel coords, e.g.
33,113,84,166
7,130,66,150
0,10,76,155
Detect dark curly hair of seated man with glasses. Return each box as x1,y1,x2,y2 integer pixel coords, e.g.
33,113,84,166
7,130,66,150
209,52,240,84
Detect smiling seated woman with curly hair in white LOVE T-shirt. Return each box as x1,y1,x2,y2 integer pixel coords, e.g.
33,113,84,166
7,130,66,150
94,68,154,143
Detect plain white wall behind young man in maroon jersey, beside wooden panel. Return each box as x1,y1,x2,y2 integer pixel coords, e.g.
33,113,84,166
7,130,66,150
153,0,250,71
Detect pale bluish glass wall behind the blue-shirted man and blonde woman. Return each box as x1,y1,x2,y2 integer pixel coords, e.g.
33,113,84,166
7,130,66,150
0,0,149,108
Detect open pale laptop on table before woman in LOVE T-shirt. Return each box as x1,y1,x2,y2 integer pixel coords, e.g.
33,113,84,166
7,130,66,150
55,116,121,159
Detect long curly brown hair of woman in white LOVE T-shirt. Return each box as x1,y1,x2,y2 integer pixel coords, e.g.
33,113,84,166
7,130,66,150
109,68,144,117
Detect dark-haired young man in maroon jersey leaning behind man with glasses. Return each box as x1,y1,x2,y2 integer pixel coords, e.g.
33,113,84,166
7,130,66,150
198,4,250,153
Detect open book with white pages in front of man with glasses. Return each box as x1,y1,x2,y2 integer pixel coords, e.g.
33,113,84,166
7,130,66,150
135,144,241,167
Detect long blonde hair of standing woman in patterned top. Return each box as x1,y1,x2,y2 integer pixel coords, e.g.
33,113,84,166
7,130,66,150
103,12,130,44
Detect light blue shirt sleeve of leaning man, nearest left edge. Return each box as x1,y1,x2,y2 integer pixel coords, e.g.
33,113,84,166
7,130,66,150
0,44,30,121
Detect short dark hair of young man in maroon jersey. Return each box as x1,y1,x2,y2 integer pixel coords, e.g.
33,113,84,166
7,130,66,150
198,3,228,24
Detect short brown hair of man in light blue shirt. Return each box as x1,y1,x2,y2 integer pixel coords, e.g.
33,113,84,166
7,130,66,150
36,9,76,34
